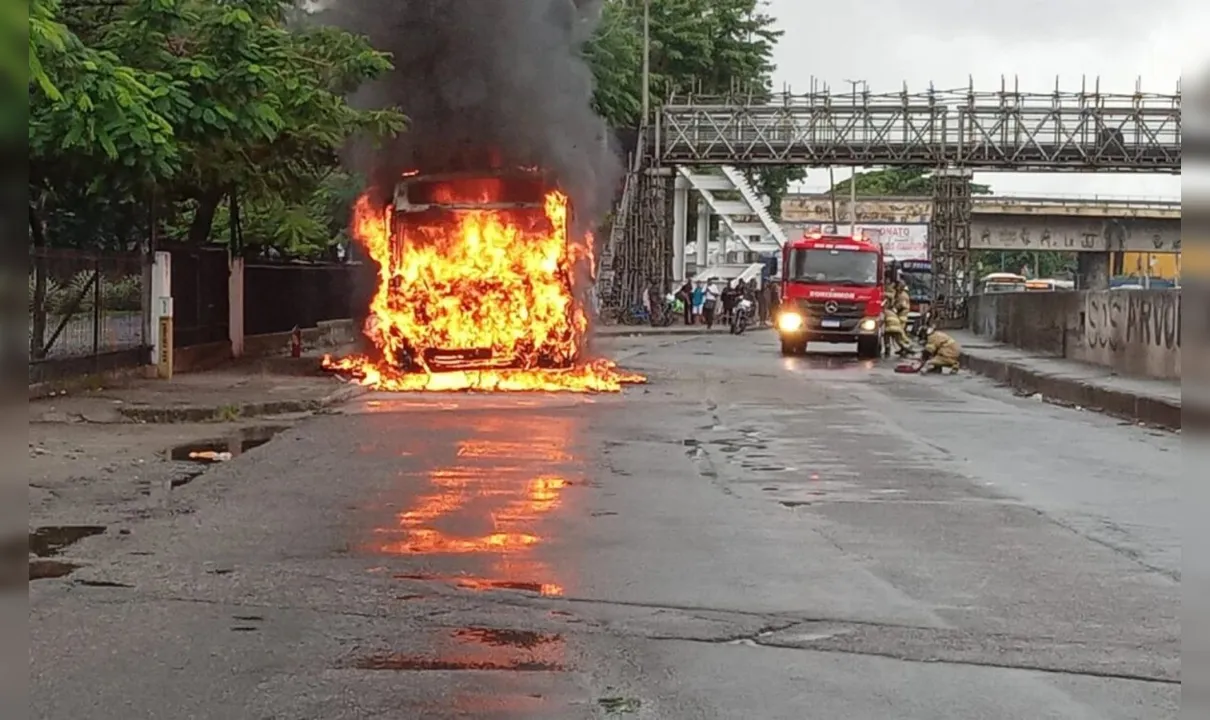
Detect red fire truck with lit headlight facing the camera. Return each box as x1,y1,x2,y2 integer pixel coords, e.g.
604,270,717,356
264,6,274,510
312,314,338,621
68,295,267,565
776,235,885,358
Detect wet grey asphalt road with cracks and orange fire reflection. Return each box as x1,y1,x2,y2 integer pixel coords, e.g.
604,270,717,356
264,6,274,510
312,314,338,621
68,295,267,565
29,333,1181,720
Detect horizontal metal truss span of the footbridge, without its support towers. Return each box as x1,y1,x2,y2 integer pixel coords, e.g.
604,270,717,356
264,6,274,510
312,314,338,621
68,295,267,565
652,82,1181,173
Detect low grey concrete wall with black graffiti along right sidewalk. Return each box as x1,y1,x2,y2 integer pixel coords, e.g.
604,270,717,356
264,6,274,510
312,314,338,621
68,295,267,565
969,290,1181,380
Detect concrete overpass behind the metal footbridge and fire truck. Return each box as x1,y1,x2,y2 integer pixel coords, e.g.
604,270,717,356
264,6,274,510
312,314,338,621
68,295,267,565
782,195,1181,253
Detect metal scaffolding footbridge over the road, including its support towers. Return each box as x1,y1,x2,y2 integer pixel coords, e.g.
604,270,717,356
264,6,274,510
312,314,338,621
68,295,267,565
599,75,1180,324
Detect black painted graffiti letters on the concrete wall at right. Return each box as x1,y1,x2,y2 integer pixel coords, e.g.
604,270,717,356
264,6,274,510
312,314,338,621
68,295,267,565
1084,290,1181,352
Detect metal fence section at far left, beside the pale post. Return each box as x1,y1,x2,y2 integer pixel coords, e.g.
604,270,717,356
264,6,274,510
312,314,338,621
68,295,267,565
29,248,148,382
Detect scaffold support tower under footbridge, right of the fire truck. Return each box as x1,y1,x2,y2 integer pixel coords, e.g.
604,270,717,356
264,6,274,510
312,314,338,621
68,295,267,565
928,169,974,327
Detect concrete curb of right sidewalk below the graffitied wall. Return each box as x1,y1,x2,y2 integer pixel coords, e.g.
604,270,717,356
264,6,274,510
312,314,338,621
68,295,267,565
961,352,1192,430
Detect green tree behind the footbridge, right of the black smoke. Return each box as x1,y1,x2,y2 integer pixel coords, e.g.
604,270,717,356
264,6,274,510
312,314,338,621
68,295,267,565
584,0,806,217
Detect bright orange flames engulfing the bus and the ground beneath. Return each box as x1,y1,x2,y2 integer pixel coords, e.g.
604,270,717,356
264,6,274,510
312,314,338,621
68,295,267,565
323,179,645,392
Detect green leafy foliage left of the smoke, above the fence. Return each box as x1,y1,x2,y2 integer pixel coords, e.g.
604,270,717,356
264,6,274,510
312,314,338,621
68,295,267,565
29,0,404,254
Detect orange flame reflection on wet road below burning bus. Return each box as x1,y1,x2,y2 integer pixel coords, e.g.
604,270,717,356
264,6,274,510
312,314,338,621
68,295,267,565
374,413,576,595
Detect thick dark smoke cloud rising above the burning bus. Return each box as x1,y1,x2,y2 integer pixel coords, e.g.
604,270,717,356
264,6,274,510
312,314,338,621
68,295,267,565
321,0,622,228
